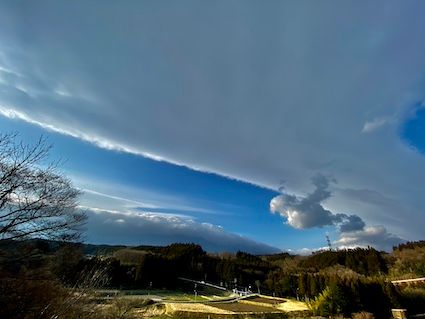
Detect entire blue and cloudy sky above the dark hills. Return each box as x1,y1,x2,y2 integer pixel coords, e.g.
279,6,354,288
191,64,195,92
0,0,425,253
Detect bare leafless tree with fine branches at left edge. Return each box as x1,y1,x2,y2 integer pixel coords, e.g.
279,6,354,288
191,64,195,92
0,134,86,240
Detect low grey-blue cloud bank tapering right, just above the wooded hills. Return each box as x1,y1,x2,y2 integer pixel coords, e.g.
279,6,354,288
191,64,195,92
85,208,280,254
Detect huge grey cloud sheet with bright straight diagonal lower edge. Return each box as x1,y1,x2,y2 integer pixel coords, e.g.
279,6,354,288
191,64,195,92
0,0,425,245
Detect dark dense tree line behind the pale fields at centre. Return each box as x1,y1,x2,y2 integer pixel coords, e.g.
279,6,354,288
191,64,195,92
56,244,278,289
